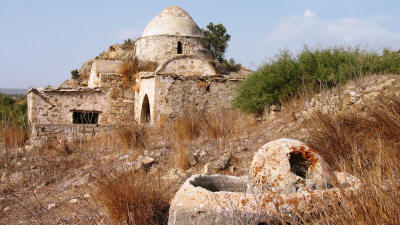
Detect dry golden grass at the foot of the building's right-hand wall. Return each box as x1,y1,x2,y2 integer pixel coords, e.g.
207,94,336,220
157,107,255,170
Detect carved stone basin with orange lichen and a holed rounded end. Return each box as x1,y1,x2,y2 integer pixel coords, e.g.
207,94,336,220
168,139,360,225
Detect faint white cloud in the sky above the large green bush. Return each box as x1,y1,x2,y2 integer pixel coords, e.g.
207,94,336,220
266,9,400,51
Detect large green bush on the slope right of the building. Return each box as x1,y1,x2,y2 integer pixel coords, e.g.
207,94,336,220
233,47,400,114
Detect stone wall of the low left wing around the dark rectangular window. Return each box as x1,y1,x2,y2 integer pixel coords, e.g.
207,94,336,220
27,74,135,132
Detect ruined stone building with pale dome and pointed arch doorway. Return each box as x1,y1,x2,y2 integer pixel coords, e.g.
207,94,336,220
27,6,247,140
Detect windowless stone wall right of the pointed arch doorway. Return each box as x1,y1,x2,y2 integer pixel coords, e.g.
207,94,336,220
154,75,242,121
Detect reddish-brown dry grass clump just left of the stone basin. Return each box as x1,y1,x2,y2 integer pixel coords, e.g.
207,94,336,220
94,171,171,225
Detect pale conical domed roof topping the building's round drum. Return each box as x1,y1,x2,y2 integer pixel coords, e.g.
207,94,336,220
142,6,203,37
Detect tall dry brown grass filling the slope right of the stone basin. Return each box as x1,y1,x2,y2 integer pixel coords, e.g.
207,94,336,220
289,94,400,224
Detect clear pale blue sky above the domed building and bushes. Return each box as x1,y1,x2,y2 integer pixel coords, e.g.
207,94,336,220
0,0,400,88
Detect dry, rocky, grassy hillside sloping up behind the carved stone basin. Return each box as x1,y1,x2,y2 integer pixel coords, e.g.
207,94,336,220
0,75,400,224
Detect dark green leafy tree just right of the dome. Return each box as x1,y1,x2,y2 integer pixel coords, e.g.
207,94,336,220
202,22,231,62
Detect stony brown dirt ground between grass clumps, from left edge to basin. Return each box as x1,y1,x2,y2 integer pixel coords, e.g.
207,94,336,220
0,106,304,224
